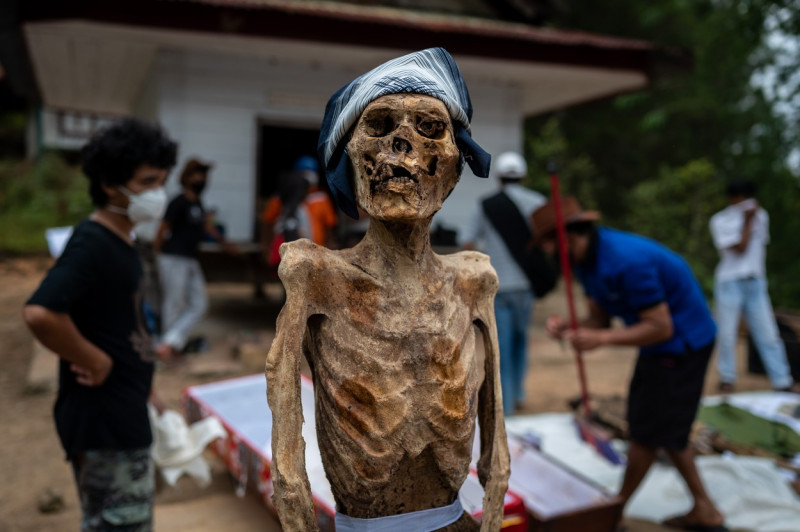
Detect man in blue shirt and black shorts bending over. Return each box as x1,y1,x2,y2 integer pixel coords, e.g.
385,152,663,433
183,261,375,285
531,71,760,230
533,198,727,531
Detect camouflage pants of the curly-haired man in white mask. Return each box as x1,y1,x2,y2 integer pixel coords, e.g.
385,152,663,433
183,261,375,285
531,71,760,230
72,448,155,532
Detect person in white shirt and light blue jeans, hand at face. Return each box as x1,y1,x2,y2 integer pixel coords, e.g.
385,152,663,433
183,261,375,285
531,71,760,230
710,180,800,393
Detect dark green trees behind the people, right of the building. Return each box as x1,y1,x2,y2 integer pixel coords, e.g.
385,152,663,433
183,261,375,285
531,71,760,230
526,0,800,308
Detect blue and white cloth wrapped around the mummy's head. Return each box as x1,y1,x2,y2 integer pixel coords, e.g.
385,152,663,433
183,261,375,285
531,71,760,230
317,48,491,218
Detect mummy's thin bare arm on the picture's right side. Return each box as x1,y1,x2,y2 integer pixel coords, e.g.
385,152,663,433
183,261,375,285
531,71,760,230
476,274,510,531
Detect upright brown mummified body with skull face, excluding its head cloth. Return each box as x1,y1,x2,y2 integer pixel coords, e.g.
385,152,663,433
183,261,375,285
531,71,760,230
267,94,508,530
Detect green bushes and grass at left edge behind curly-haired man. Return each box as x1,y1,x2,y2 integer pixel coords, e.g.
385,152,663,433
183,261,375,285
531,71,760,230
0,153,92,253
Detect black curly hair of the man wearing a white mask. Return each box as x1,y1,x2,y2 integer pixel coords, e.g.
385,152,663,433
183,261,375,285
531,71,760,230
81,118,178,207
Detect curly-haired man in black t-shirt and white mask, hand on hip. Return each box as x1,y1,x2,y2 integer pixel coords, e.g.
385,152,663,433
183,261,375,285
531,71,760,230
23,120,177,531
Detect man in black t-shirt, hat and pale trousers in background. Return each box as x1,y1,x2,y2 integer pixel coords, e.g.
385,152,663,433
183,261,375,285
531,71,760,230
153,159,234,360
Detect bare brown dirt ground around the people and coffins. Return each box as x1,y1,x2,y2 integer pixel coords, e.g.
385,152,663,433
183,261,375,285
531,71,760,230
0,258,780,532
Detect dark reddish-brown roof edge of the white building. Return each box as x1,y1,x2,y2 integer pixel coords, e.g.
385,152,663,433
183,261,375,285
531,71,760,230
22,0,688,79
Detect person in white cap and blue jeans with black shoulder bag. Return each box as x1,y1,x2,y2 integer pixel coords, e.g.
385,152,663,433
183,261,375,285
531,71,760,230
459,152,547,414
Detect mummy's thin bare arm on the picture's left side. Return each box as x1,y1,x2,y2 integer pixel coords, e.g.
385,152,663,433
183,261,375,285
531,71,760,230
266,248,317,532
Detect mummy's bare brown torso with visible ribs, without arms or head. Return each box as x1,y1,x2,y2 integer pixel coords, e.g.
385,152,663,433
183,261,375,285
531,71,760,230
290,243,490,517
